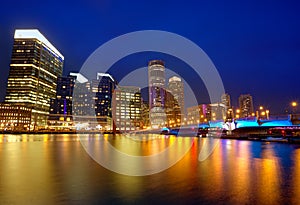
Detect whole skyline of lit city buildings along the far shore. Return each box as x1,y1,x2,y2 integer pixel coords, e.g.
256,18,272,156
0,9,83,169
1,29,297,131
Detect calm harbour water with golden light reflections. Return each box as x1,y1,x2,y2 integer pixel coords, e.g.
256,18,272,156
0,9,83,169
0,134,300,204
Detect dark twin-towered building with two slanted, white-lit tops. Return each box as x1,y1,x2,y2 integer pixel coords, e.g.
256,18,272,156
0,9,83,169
70,73,117,130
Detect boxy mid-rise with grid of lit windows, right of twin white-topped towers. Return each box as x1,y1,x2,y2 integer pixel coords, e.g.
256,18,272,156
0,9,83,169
113,86,141,132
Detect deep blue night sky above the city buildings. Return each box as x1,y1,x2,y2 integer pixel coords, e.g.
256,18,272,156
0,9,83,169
0,0,300,112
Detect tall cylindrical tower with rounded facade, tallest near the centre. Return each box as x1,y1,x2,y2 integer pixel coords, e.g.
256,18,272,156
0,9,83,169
148,60,166,128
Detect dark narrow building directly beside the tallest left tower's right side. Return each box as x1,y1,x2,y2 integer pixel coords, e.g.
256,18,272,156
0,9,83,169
48,75,76,129
